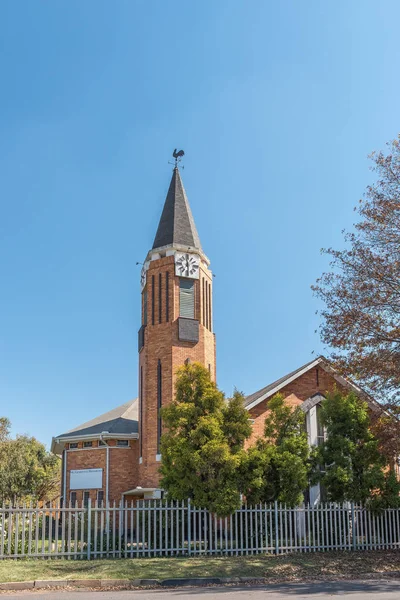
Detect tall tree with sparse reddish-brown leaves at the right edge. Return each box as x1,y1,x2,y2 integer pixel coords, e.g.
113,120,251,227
313,135,400,408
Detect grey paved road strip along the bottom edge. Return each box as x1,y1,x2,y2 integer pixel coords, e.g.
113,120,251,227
0,579,400,600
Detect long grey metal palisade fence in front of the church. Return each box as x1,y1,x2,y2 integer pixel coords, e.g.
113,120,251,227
0,500,400,560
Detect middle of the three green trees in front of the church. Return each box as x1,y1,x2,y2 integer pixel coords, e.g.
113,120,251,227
241,394,309,506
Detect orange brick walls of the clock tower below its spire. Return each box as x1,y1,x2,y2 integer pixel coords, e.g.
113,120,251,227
139,256,216,487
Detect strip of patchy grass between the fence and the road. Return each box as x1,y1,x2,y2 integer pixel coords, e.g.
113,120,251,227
0,550,400,582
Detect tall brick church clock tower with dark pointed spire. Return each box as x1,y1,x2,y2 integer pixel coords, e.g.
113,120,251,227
138,165,216,490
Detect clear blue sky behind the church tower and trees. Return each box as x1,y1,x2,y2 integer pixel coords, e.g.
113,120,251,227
0,0,400,444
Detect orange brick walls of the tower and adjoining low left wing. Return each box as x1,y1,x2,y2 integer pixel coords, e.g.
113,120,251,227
58,248,216,502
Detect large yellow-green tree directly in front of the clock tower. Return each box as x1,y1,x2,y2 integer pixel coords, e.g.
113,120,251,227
160,364,251,516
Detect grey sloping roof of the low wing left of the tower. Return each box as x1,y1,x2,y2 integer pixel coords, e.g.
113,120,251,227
57,398,139,439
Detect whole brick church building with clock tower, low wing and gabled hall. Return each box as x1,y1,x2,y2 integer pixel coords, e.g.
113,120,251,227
51,164,378,504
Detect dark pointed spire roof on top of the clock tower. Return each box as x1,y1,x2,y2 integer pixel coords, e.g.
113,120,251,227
153,167,201,250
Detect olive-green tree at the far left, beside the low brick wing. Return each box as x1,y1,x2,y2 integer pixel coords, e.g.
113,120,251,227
0,417,60,504
